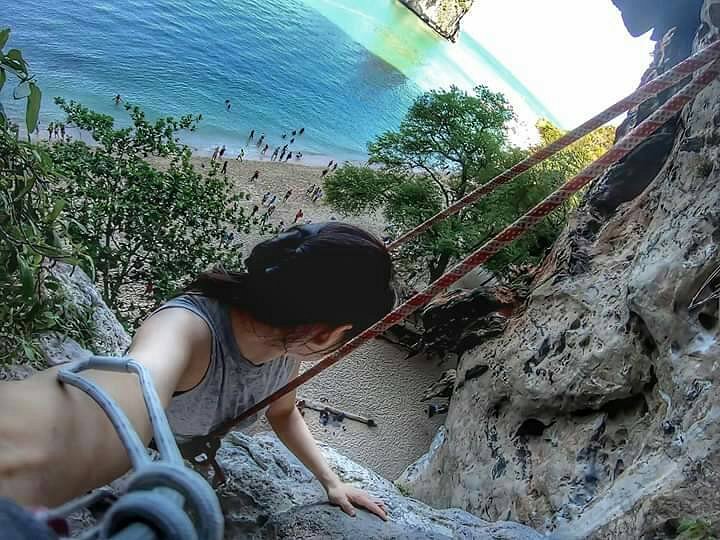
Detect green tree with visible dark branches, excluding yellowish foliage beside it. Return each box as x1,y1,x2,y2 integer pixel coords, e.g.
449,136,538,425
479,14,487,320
325,86,514,279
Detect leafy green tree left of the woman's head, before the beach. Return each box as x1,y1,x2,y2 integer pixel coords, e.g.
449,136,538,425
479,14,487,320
51,98,250,322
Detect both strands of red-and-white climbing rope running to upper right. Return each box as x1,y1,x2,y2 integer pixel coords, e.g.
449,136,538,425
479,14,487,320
222,47,720,426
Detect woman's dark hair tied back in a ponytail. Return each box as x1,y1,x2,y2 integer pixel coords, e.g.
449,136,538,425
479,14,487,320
186,222,395,337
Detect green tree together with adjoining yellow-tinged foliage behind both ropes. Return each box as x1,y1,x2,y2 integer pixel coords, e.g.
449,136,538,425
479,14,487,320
325,86,614,279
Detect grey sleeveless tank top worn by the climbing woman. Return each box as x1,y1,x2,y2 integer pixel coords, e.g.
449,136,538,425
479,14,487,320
153,294,296,443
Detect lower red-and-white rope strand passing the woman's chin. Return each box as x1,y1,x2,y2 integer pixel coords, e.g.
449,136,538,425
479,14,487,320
231,52,720,428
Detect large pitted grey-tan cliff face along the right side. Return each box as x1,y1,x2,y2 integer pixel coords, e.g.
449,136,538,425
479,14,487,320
400,0,720,538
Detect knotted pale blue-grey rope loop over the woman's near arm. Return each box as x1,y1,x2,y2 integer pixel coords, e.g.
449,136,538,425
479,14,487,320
37,356,223,540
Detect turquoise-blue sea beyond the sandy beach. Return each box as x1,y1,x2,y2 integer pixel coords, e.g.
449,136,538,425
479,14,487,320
2,0,553,163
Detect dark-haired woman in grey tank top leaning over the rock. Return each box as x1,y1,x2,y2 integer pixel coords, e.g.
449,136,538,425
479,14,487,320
0,222,395,518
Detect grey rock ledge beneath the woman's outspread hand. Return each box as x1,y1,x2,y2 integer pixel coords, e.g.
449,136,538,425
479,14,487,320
218,432,541,540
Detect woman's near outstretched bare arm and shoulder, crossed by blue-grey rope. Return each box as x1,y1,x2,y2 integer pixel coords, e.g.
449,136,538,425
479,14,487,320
0,309,210,506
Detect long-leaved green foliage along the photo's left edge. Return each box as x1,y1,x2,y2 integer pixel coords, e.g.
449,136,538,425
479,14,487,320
0,29,89,365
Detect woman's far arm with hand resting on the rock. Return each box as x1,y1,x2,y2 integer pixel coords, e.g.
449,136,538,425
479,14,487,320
267,369,387,519
